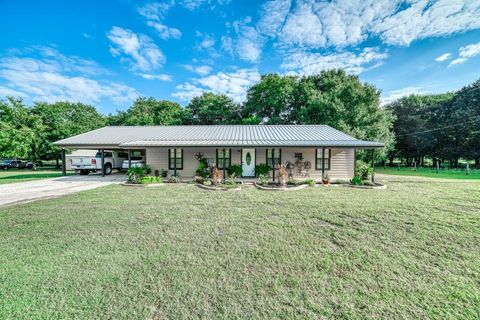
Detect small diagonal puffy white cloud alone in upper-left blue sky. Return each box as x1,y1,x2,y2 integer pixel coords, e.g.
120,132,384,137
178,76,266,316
107,27,166,71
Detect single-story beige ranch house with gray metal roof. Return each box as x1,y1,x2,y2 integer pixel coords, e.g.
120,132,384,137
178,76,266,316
55,125,384,180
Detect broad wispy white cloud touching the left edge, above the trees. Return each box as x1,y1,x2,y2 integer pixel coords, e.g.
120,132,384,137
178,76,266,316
0,47,138,103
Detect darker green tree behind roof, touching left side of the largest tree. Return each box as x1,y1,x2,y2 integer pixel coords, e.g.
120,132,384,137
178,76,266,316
243,74,297,124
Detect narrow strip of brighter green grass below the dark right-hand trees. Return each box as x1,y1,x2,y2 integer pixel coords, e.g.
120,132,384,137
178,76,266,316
375,166,480,180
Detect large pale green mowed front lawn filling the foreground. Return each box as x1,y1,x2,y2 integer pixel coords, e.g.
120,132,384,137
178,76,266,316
0,176,480,319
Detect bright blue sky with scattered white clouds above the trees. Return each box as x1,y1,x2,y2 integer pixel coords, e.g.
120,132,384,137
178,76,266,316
0,0,480,113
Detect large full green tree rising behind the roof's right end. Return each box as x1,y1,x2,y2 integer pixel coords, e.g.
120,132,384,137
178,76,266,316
290,70,394,157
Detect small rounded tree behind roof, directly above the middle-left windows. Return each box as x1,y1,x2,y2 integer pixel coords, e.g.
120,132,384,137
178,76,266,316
183,93,241,125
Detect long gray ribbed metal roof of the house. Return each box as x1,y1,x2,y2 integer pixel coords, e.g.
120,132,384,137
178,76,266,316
55,125,384,148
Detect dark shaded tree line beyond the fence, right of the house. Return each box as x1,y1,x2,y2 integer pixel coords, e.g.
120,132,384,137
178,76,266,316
386,80,480,168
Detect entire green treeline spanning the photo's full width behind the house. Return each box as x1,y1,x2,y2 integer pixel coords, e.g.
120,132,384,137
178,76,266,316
0,70,480,169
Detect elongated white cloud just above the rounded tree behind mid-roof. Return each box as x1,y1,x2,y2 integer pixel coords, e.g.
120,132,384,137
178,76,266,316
172,69,260,102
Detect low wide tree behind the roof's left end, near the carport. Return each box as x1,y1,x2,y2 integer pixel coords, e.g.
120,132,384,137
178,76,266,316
112,97,183,126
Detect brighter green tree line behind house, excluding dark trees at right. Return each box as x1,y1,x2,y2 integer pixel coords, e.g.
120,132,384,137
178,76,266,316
0,70,394,165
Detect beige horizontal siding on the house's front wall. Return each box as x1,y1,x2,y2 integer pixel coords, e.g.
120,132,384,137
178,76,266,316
146,148,354,180
